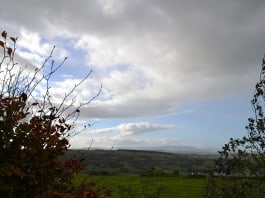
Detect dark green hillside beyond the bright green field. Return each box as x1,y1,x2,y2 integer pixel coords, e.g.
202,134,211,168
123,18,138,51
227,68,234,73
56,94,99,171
64,150,217,174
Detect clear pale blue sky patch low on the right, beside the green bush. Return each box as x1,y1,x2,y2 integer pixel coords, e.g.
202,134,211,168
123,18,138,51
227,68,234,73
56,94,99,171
168,97,252,148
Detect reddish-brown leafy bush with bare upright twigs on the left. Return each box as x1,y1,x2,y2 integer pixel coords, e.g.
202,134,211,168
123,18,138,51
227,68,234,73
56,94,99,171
0,31,104,197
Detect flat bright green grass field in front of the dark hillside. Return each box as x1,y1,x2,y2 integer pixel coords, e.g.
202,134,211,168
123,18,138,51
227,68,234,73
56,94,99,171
73,175,205,198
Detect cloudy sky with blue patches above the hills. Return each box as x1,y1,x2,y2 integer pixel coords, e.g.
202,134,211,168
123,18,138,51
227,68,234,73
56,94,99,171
0,0,265,150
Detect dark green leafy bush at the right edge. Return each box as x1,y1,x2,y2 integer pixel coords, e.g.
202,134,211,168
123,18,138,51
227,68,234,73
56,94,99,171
206,56,265,197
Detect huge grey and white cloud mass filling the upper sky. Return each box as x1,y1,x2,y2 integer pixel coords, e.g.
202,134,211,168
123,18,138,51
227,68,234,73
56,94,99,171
0,0,265,118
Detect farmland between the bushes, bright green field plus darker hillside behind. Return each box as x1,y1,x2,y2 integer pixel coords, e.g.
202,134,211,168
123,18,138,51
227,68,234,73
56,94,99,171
65,150,216,198
